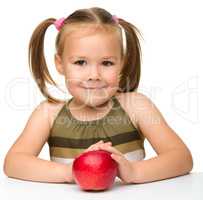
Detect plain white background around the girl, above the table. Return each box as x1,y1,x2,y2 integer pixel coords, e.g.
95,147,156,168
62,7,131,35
0,0,203,181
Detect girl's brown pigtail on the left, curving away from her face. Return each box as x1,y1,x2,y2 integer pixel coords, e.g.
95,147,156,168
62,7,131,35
28,18,60,103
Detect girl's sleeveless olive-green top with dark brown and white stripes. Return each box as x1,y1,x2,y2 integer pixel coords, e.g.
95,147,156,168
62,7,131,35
48,96,145,163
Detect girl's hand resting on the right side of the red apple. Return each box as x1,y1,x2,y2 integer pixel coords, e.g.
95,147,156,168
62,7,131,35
97,143,134,183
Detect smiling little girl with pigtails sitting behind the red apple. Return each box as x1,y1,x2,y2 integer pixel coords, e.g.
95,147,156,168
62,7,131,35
4,7,193,184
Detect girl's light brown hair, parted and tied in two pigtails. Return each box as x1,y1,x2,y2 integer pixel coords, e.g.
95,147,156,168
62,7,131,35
28,7,141,103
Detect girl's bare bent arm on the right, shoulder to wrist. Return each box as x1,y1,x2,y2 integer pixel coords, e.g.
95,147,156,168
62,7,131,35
128,93,193,183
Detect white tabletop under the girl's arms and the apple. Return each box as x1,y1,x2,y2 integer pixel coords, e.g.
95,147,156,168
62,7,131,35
0,173,203,200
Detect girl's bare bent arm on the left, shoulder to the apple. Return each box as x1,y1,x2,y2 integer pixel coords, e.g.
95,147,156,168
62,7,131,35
4,102,74,182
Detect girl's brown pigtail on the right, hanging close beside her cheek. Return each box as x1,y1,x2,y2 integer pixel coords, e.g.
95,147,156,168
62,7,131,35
119,19,141,92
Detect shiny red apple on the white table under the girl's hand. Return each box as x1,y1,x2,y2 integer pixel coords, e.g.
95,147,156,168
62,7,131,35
72,150,118,190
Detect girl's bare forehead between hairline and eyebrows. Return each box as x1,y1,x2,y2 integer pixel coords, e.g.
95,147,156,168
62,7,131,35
64,25,120,57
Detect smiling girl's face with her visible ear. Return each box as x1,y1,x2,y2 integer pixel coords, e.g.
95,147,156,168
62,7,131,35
55,28,122,107
